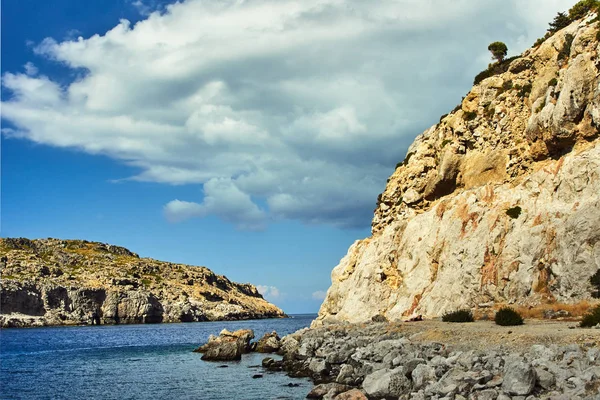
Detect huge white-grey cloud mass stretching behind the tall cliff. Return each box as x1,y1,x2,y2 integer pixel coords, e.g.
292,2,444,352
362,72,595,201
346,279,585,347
2,0,575,229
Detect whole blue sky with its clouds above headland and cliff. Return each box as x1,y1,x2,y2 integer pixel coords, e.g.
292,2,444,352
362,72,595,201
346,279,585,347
0,0,576,313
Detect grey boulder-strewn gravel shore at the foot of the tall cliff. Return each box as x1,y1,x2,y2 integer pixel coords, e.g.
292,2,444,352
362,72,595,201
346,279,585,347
199,321,600,400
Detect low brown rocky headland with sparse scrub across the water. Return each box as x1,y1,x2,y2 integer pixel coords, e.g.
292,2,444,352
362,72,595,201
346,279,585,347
0,239,285,327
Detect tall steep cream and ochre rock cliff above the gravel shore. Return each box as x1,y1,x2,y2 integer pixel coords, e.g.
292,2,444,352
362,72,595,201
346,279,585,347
315,17,600,325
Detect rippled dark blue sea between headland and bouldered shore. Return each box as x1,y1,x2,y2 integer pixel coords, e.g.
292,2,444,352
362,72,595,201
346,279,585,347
0,315,316,400
